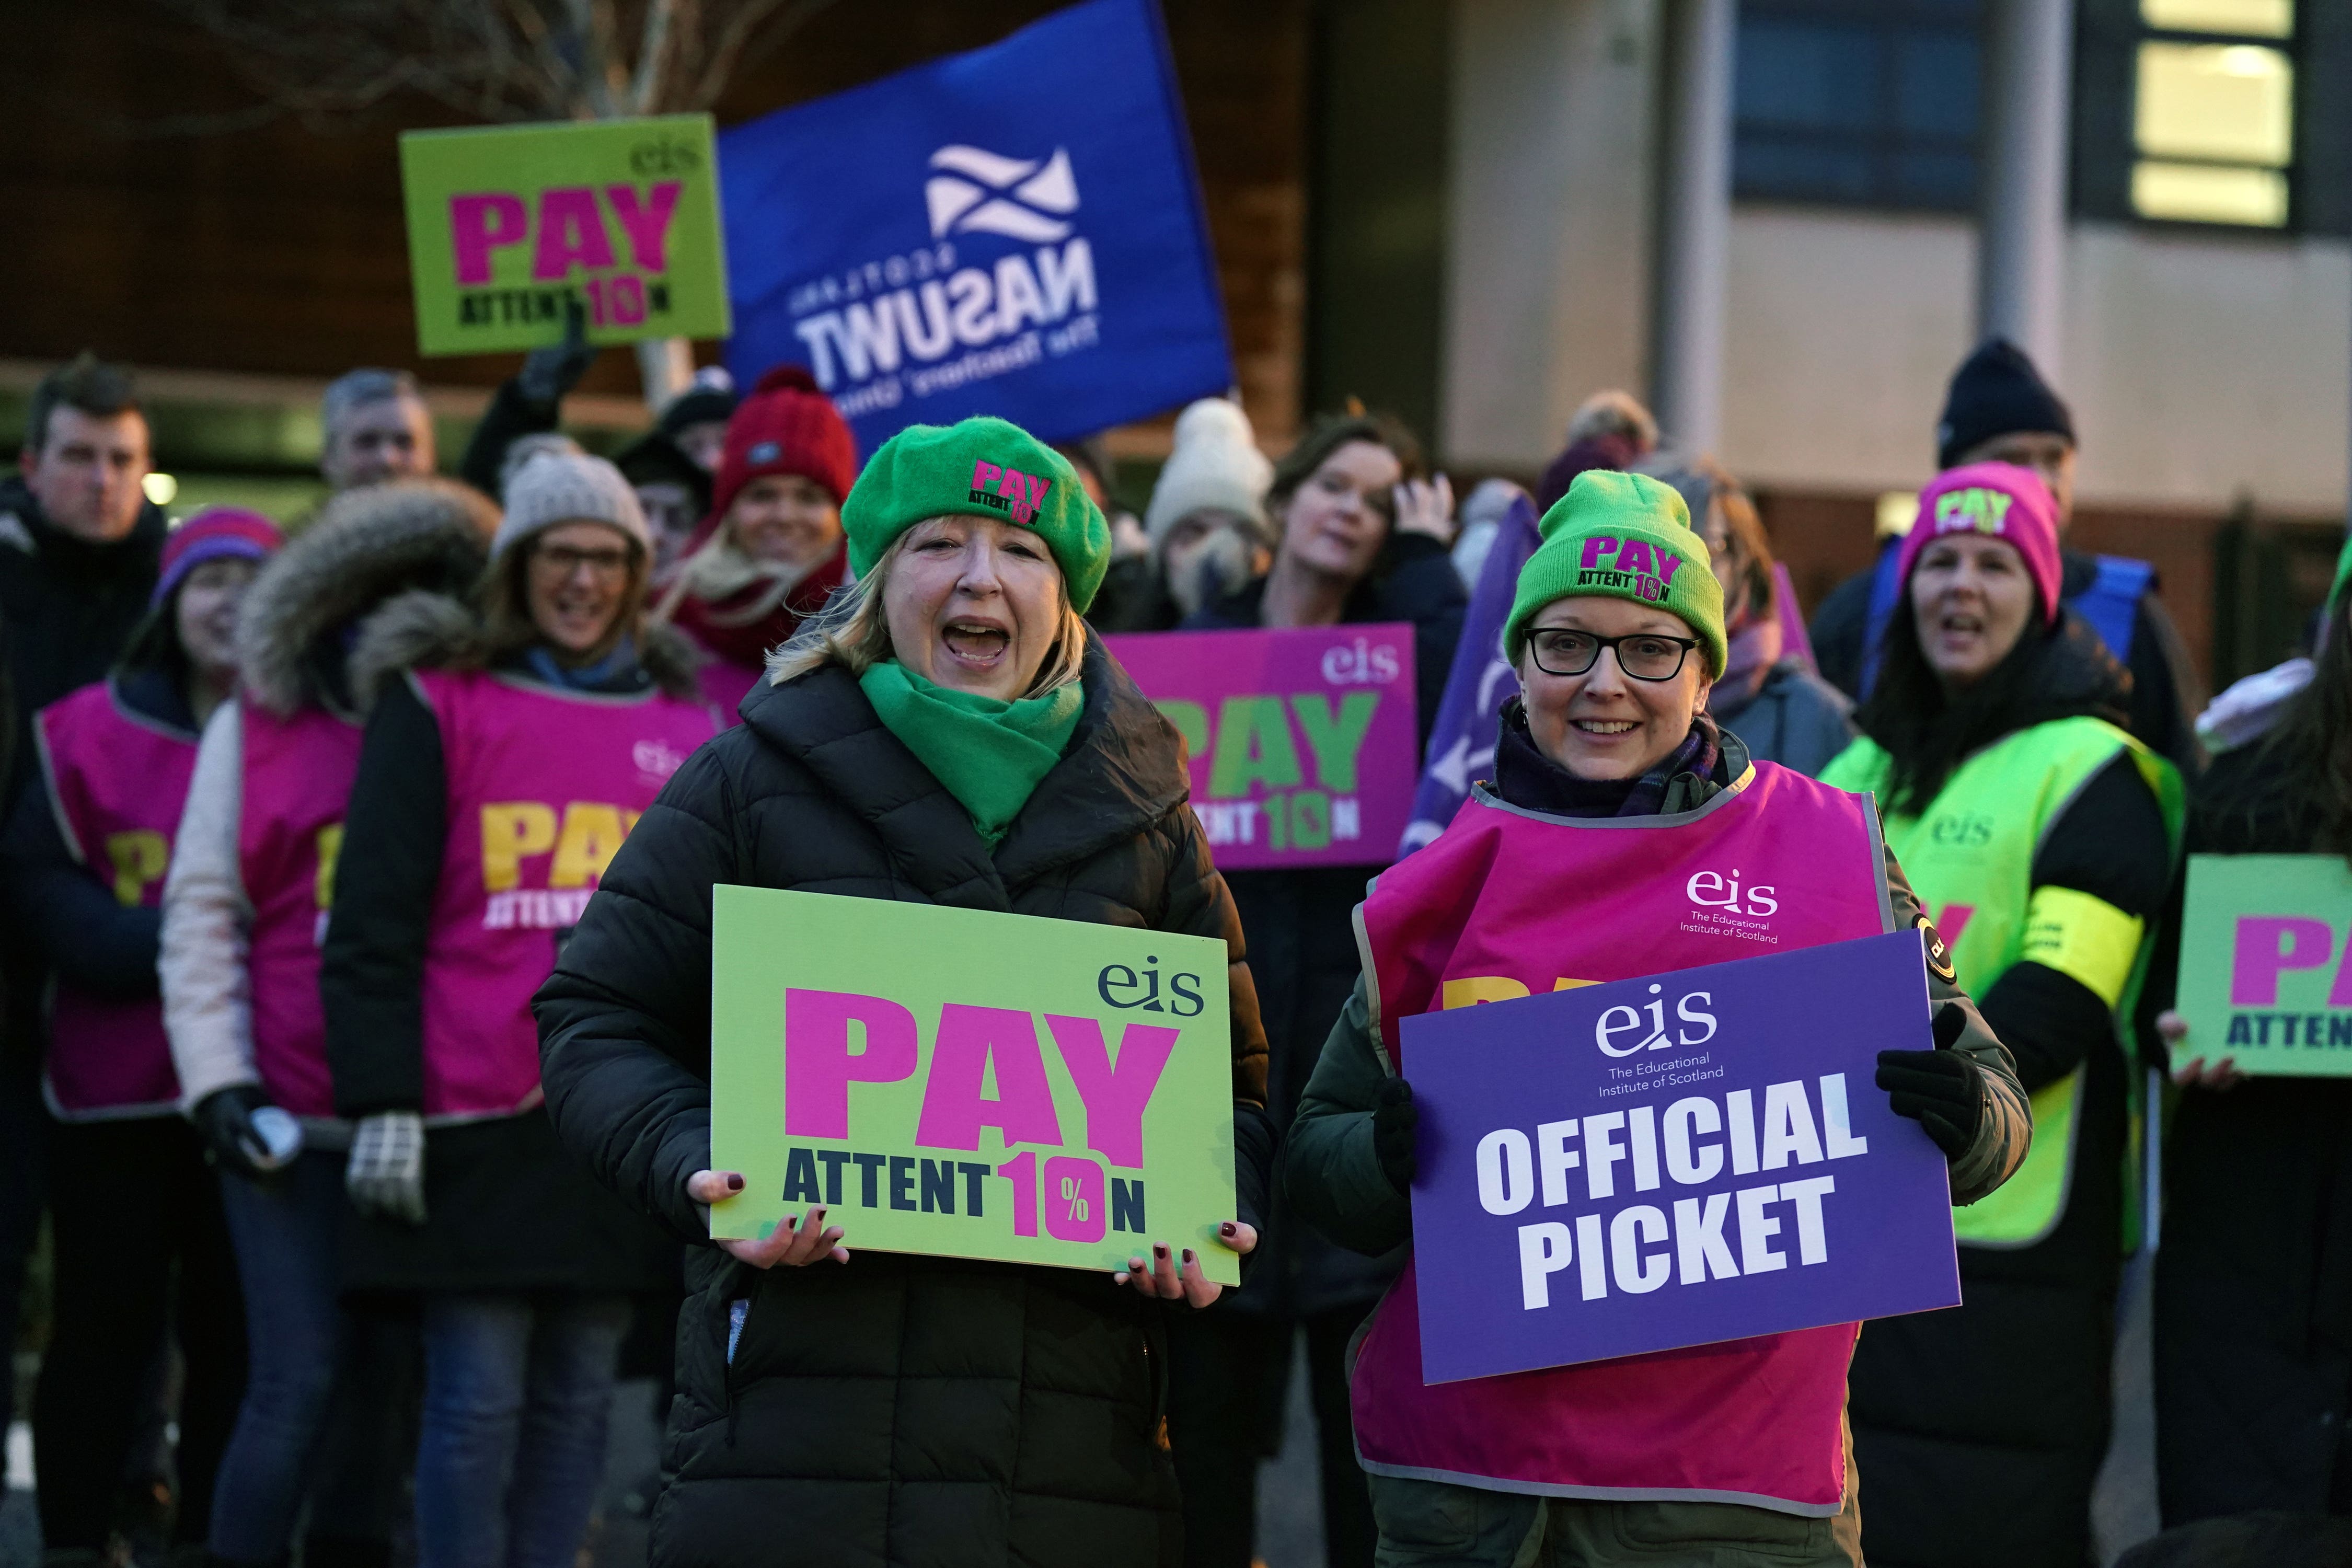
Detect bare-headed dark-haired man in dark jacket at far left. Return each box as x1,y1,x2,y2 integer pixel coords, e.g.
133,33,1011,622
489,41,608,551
0,353,167,1425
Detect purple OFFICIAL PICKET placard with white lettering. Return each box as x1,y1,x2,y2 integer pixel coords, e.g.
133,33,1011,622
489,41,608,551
1402,931,1959,1382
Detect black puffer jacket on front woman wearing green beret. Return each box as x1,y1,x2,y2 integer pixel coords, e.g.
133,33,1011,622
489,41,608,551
536,644,1273,1568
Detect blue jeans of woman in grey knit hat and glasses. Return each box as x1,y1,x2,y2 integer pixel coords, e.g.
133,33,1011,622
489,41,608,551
417,1295,628,1568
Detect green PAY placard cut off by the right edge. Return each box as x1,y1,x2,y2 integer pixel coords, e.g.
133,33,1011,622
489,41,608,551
2173,856,2352,1077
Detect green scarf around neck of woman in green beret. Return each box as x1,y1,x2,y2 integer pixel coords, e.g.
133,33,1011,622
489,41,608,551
859,658,1087,849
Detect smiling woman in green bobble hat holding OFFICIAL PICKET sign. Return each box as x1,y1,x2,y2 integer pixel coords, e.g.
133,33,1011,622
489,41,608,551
1284,470,2030,1568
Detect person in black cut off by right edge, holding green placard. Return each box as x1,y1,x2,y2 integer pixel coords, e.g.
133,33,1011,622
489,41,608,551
2145,543,2352,1528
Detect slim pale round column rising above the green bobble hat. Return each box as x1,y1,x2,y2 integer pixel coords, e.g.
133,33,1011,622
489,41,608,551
1651,0,1738,452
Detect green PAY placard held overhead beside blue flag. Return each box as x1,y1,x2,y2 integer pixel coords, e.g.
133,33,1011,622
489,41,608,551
400,115,729,355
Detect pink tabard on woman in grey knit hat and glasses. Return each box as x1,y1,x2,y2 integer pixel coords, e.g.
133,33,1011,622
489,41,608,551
412,670,718,1121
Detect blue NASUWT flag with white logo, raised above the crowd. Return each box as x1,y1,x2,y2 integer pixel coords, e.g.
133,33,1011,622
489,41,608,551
720,0,1232,452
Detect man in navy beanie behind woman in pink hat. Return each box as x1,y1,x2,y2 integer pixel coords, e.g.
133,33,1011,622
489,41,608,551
1811,339,2204,778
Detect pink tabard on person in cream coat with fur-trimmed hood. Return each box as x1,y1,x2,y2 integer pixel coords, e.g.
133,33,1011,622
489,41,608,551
238,700,360,1116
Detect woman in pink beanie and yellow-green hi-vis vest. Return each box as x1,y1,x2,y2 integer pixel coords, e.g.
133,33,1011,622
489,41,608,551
1823,463,2183,1568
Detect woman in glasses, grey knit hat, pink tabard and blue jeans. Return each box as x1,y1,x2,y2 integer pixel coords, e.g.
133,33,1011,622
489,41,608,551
320,452,718,1568
